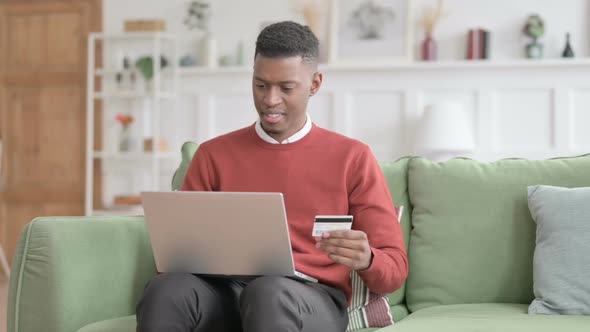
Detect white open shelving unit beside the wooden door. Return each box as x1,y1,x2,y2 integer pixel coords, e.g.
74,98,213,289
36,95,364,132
85,33,178,215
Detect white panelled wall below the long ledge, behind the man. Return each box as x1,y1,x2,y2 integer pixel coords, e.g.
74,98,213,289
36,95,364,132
176,60,590,161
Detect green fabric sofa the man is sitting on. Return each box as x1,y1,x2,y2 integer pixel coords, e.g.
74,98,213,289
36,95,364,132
8,144,590,332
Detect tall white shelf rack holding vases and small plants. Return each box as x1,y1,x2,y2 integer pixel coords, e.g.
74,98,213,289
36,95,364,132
84,32,182,216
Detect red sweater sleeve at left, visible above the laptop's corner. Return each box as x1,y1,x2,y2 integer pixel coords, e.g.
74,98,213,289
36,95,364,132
180,144,216,191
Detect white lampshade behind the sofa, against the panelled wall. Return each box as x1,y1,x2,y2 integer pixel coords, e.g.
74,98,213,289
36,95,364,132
414,102,475,161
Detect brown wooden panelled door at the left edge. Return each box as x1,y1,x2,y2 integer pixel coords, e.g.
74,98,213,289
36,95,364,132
0,0,102,261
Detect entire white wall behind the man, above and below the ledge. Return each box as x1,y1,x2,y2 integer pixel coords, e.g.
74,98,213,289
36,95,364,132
95,0,590,210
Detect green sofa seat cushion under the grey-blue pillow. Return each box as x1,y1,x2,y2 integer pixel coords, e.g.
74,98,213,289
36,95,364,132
377,303,590,332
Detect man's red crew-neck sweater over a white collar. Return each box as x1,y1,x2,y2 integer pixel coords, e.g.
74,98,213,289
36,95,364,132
182,125,408,301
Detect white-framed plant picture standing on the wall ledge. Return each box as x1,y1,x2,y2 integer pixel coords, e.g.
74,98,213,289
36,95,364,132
329,0,413,65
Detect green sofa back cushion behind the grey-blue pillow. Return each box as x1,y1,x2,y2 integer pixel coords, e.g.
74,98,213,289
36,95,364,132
406,155,590,311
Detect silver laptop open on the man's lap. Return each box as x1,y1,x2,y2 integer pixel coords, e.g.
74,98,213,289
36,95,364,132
141,191,317,282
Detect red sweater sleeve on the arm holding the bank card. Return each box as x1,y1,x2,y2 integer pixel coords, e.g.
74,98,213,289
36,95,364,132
349,145,408,293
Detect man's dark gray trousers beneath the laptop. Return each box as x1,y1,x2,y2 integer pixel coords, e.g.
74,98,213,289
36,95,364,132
137,273,348,332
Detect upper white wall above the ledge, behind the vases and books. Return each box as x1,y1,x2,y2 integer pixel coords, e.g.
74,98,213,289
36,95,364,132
104,0,590,61
